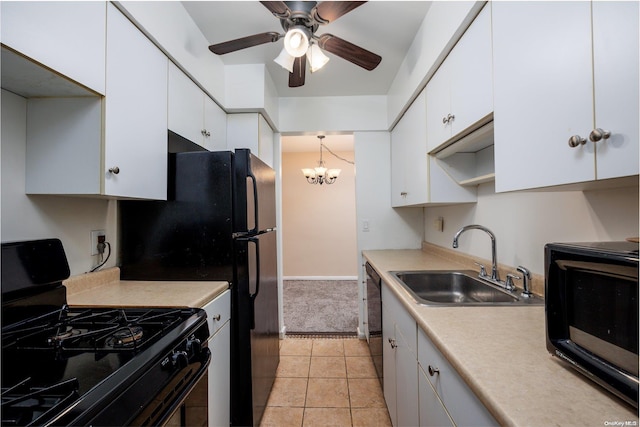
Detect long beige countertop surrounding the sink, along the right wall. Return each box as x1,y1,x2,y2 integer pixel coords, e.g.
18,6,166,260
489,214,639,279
363,245,638,426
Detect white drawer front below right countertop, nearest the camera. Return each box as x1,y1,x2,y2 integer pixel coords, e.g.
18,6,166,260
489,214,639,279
418,329,498,426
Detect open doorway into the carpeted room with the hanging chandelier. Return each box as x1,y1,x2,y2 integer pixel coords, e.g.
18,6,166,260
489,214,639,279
281,135,359,336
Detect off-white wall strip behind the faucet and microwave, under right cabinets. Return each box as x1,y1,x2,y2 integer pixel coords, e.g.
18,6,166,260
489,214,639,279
424,183,639,274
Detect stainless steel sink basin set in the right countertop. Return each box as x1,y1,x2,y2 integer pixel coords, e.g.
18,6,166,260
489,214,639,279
391,270,544,306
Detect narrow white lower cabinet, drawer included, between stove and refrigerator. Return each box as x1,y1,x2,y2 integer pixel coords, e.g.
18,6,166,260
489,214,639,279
204,290,231,427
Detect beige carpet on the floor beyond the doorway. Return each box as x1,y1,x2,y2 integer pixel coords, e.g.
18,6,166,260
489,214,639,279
283,280,358,336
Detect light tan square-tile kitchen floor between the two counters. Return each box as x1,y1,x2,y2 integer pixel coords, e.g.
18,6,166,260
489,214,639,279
261,338,391,427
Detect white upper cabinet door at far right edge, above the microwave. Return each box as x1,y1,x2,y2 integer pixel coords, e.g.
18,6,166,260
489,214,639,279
585,1,640,179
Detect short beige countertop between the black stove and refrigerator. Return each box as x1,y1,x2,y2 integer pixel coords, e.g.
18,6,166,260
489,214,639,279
63,267,229,308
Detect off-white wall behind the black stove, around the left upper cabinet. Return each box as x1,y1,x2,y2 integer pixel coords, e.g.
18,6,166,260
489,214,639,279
0,90,117,275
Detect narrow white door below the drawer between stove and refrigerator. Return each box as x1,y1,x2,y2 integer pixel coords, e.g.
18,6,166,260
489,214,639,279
207,322,231,427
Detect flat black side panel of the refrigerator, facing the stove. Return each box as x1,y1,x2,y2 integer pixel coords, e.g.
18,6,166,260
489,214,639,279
119,152,234,281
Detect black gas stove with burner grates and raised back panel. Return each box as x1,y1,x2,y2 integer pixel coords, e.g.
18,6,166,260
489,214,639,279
2,239,211,426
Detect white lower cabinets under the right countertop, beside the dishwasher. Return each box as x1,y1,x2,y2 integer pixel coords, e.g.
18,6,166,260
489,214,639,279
382,282,498,427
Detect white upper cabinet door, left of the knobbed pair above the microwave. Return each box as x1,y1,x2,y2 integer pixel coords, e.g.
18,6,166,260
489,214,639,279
491,2,595,192
